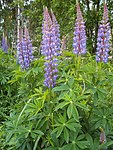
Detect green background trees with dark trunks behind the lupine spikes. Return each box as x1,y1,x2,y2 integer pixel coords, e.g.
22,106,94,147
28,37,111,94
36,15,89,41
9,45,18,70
0,0,113,53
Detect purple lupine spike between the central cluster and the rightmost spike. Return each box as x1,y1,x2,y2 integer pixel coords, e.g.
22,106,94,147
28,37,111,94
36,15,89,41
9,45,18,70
73,3,86,55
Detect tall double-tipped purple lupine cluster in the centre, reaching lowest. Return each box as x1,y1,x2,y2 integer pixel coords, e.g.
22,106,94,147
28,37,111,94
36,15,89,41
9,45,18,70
41,7,60,88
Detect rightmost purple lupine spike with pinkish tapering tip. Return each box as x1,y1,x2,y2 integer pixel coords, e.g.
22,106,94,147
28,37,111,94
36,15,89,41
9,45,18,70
96,4,110,63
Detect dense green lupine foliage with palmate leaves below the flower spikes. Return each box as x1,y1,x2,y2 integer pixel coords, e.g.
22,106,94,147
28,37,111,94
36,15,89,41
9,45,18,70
0,48,113,150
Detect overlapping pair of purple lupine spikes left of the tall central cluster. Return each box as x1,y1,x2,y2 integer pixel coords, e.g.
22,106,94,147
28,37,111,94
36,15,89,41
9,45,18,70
17,27,33,70
